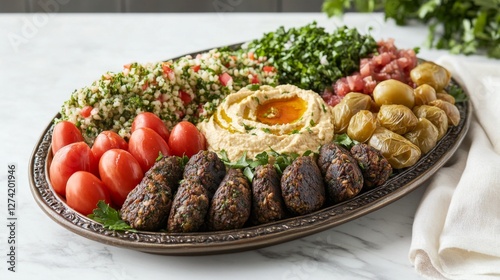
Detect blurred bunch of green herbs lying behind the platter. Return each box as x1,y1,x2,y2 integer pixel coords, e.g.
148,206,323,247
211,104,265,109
323,0,500,59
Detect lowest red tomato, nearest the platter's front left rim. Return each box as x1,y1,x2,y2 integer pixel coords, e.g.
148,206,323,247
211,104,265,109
66,171,111,216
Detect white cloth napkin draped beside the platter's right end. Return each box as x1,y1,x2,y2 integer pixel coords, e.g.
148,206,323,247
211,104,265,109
409,56,500,279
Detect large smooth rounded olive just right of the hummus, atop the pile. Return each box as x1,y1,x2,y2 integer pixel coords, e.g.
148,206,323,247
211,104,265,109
373,80,415,109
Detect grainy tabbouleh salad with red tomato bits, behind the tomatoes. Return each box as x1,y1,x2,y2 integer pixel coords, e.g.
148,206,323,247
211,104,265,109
60,48,276,144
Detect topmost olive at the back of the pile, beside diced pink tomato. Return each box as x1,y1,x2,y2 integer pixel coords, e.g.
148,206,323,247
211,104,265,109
410,61,451,92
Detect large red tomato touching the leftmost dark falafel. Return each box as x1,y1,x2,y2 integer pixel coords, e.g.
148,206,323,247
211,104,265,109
99,149,144,208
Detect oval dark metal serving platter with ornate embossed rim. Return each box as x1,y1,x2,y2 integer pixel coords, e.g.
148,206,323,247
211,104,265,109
29,44,472,255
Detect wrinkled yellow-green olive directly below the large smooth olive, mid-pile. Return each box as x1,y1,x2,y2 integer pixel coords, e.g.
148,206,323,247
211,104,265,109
377,104,418,135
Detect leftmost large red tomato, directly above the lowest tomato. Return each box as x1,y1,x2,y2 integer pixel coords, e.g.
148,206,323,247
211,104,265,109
49,142,98,196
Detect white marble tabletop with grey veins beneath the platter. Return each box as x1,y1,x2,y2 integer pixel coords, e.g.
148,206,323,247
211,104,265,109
0,13,464,280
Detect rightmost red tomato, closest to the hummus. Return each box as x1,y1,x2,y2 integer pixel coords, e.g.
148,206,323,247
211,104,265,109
168,121,206,157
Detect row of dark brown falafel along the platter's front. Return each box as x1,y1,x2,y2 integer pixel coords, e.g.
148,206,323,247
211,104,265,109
120,142,392,233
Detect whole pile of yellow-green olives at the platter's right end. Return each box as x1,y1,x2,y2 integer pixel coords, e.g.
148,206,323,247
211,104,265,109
333,62,460,169
